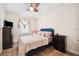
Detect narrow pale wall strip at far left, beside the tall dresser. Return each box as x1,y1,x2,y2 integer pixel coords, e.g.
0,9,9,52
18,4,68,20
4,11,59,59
0,4,5,52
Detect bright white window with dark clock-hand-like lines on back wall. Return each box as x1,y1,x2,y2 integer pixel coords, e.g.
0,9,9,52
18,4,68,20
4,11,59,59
19,19,30,35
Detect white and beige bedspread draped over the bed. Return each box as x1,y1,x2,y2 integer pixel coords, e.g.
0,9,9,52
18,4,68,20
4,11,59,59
19,35,49,56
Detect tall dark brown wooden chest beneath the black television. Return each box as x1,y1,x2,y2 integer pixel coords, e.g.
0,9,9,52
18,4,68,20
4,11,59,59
3,27,12,50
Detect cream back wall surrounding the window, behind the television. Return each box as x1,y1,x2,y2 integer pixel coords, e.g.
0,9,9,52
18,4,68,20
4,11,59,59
5,11,37,42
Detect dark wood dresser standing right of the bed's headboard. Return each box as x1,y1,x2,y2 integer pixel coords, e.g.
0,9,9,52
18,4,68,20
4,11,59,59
54,35,66,53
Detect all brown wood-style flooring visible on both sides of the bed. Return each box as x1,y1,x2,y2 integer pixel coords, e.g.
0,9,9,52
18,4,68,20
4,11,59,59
0,47,76,56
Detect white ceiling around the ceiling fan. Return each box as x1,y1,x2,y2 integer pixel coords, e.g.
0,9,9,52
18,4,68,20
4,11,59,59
3,3,61,17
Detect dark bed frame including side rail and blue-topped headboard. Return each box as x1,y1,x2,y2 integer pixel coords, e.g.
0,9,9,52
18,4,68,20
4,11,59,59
25,28,54,56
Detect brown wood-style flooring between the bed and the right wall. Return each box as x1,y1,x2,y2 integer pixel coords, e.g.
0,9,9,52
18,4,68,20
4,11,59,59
34,47,76,56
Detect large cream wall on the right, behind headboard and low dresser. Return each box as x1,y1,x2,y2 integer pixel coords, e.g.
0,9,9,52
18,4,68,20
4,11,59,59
37,4,79,55
